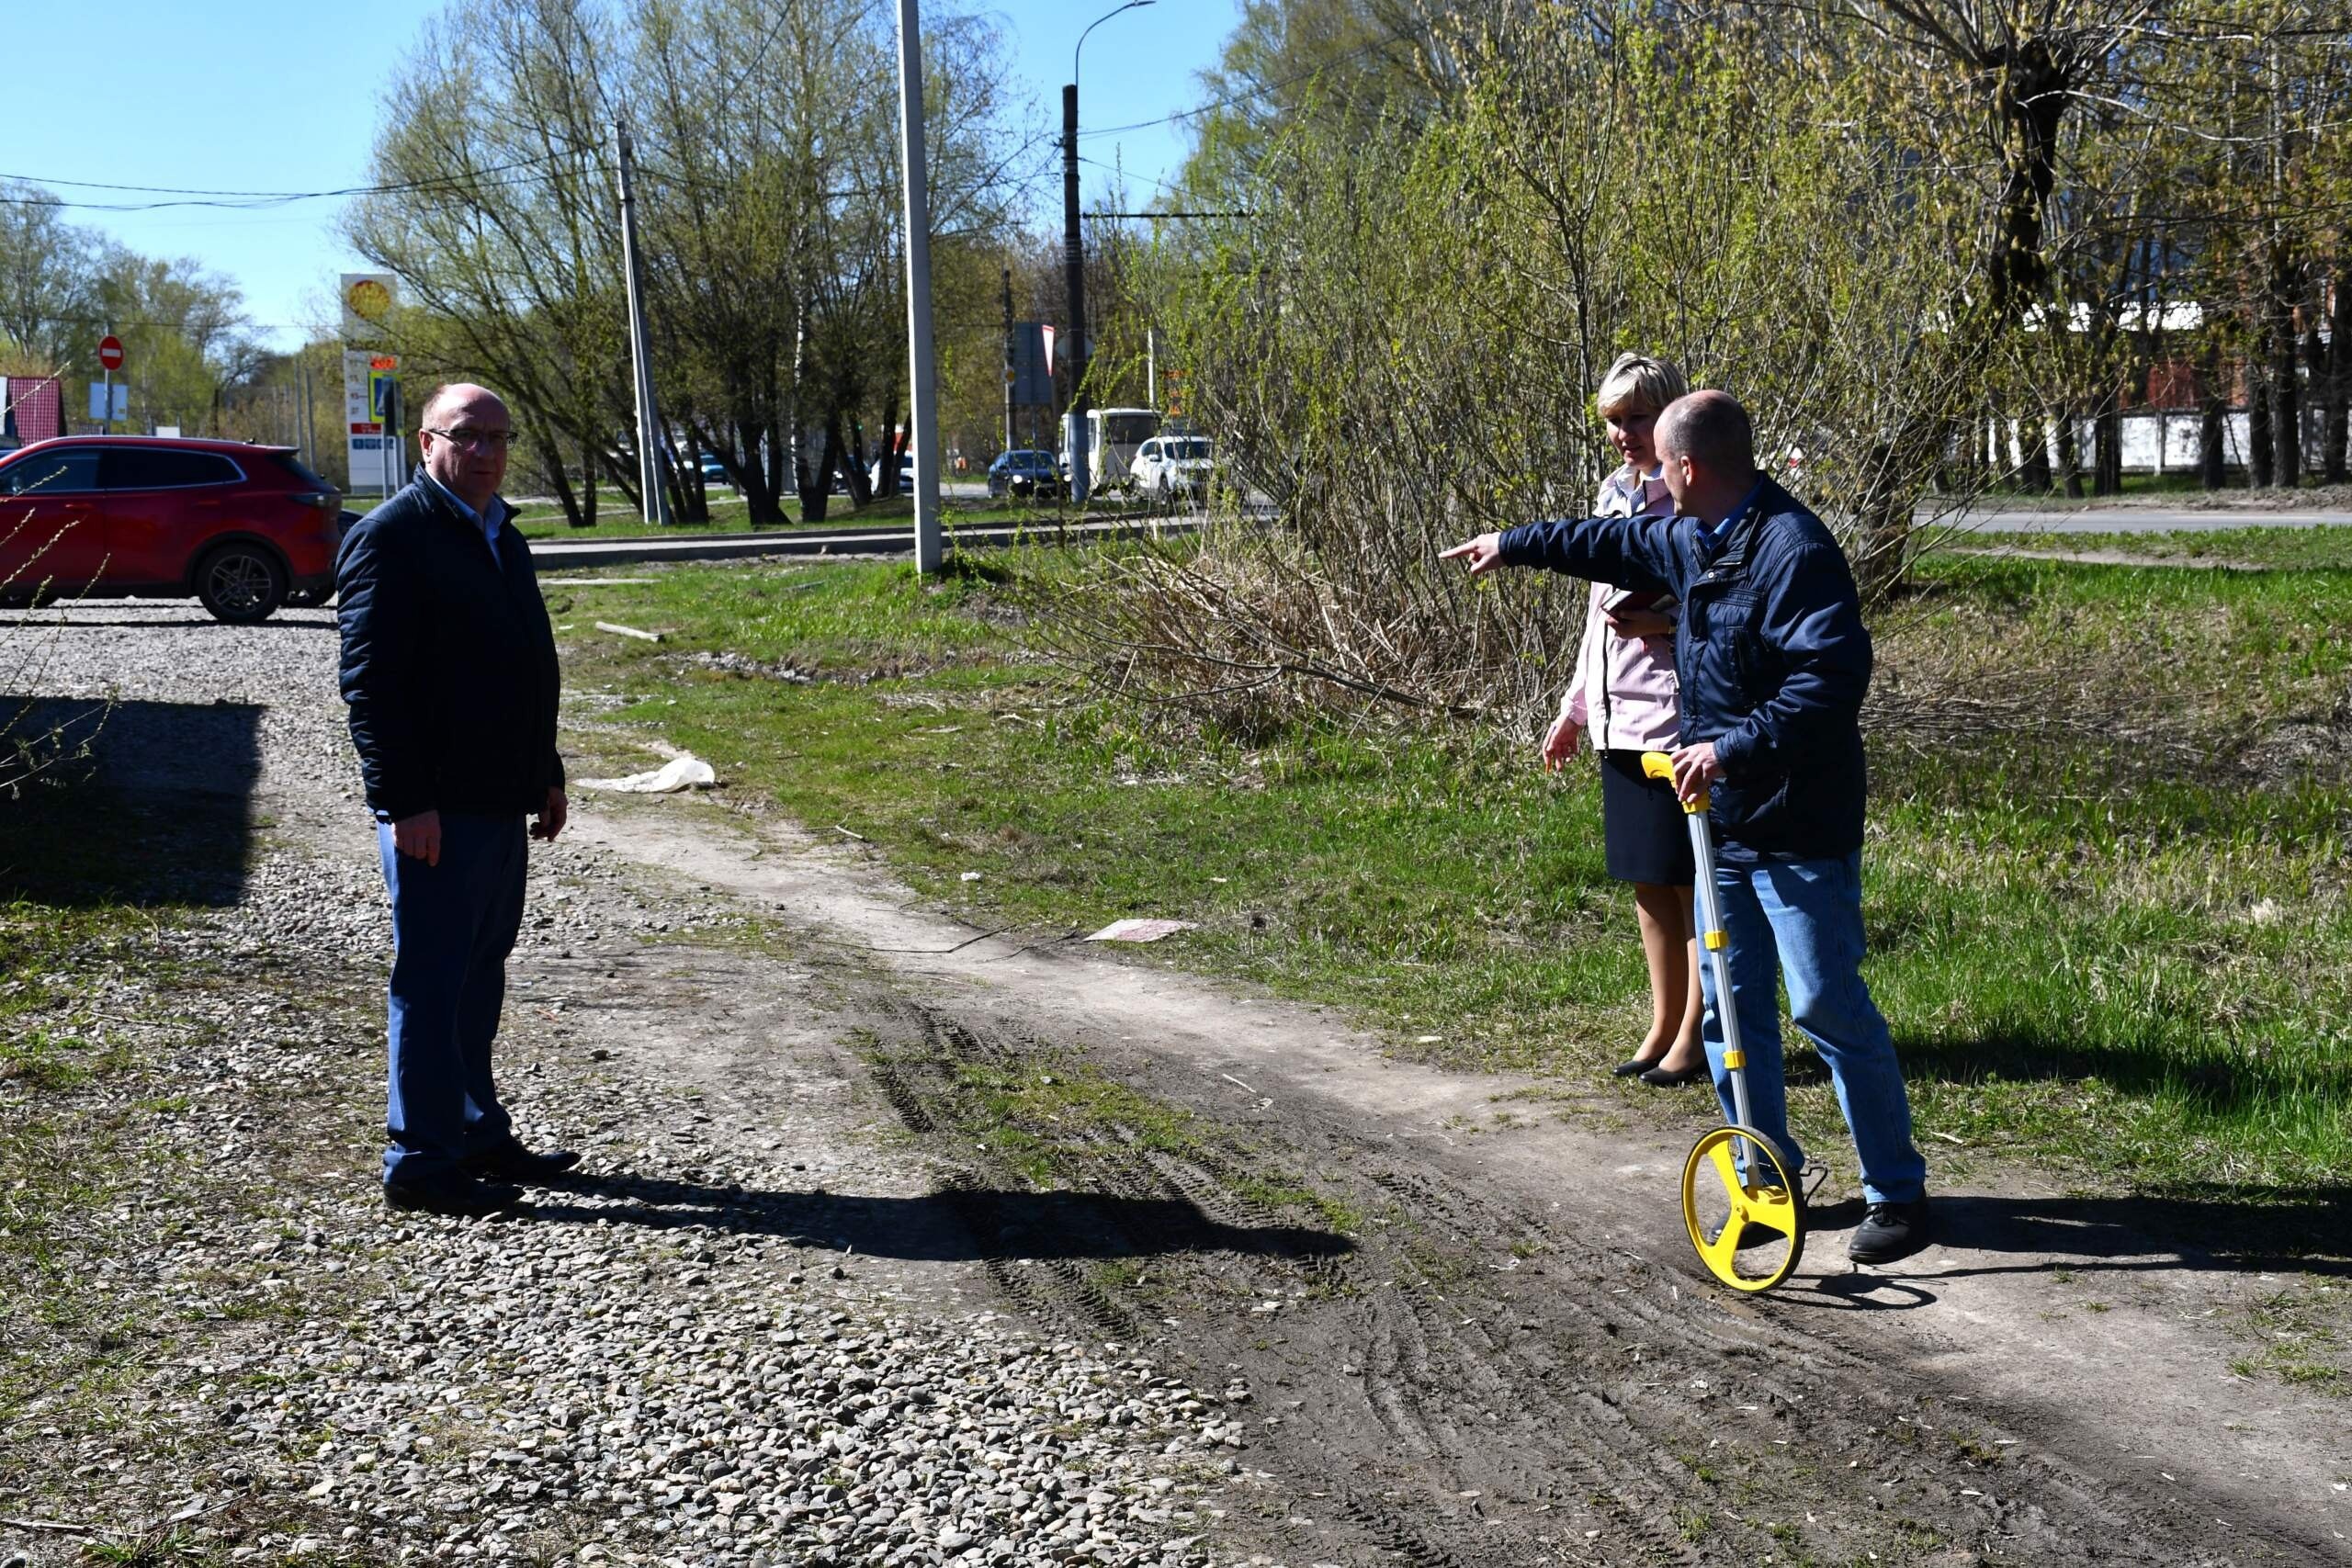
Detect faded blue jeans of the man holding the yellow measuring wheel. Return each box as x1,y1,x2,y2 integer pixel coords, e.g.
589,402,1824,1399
1701,851,1927,1203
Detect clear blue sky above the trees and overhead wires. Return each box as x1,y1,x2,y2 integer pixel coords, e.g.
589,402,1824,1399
0,0,1239,348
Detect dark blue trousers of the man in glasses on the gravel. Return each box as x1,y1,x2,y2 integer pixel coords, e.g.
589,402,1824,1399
377,811,526,1182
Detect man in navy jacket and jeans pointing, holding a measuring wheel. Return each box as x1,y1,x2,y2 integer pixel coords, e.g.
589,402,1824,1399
1444,390,1928,1262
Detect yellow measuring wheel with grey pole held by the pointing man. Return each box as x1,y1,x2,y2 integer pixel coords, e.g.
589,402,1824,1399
1642,752,1804,1291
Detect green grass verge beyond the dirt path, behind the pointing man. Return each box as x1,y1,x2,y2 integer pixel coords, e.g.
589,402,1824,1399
555,555,2352,1218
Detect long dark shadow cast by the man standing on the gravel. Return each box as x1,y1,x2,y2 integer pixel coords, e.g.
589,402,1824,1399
520,1170,1355,1262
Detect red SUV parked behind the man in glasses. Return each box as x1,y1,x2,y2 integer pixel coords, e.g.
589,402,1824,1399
0,434,341,626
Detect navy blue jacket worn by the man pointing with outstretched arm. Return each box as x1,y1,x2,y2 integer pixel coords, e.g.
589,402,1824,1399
1503,479,1870,865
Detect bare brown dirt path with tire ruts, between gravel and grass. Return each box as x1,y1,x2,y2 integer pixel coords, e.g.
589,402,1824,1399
581,802,2352,1563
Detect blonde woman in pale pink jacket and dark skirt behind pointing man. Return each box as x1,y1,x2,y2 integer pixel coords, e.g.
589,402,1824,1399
1543,355,1708,1089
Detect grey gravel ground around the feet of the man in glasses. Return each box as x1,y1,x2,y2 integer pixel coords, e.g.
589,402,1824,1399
0,604,1263,1563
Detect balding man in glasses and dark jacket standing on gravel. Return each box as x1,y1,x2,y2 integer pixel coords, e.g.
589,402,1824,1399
334,383,579,1213
